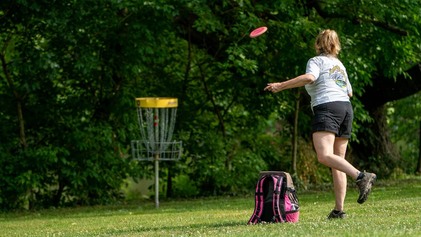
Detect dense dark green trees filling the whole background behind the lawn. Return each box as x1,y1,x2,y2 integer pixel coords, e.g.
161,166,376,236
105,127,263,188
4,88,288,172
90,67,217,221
0,0,421,208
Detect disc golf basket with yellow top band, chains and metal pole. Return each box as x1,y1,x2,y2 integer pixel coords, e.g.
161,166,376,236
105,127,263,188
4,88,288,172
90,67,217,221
131,97,182,208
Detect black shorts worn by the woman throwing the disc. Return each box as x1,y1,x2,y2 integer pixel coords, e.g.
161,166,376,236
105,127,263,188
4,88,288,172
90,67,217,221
312,101,354,138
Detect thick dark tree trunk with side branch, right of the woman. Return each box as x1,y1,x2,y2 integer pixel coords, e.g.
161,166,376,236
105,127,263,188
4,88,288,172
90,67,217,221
351,64,421,177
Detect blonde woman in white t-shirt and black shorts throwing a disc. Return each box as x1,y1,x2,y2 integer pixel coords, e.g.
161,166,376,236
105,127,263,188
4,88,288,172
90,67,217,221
265,29,376,219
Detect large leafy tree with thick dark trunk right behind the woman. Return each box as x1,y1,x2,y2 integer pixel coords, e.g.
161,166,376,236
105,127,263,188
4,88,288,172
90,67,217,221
171,1,421,176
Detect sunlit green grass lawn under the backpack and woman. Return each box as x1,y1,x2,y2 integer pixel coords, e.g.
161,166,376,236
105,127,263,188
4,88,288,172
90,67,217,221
0,177,421,237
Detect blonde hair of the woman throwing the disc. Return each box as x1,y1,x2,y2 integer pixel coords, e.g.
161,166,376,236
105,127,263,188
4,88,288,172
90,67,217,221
314,29,341,57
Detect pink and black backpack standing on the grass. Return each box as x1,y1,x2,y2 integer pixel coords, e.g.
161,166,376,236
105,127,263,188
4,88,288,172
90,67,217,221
247,171,300,224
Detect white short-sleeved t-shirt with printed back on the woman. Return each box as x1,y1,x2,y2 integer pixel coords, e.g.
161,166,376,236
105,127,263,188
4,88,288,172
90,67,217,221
305,55,352,107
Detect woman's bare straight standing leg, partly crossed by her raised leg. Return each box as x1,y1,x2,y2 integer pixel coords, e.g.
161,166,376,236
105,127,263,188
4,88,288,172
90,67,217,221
332,137,348,211
